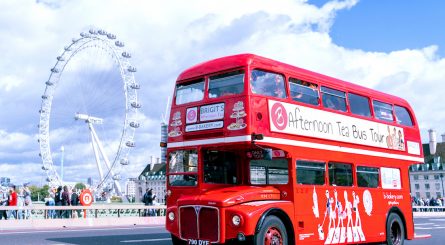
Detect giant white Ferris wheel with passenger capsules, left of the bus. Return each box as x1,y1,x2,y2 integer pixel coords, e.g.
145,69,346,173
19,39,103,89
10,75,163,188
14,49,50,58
38,29,141,196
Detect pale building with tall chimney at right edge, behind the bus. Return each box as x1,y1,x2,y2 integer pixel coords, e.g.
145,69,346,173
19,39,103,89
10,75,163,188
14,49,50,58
410,130,445,199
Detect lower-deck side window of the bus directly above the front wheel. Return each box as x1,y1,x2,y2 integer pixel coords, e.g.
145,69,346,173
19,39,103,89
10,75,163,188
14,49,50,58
250,159,289,185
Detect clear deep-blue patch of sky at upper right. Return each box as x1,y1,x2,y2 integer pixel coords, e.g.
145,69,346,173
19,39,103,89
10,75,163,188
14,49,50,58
309,0,445,57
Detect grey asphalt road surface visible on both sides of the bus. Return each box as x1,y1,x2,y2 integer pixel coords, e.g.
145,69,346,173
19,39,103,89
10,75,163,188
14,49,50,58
0,217,445,245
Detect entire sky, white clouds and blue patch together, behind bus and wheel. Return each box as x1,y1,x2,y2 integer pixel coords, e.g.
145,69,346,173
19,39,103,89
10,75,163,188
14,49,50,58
0,0,445,186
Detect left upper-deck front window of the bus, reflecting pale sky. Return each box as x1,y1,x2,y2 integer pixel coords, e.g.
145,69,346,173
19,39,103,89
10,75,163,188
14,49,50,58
176,78,204,105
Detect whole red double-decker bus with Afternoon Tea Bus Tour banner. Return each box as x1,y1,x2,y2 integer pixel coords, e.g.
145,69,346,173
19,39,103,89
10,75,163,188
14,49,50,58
166,54,423,244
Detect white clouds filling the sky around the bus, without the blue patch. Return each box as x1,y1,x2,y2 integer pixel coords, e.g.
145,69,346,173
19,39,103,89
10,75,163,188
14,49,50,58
0,0,445,186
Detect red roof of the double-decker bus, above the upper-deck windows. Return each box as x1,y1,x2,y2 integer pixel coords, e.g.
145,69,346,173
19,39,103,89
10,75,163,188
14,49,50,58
177,54,409,107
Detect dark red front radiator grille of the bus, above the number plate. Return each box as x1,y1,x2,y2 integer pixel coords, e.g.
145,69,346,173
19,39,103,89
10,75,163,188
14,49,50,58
179,206,220,242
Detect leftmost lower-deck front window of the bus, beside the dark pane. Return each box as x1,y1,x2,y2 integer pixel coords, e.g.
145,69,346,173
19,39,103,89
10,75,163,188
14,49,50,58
168,150,198,186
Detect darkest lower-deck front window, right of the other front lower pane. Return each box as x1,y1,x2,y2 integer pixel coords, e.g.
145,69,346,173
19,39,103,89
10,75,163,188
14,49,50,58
203,151,237,184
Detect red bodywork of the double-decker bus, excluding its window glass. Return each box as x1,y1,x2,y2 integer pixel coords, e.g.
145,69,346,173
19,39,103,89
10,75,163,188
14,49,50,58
166,54,423,244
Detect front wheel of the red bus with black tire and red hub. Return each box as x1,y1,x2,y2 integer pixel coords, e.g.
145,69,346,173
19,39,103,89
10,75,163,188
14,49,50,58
253,215,288,245
